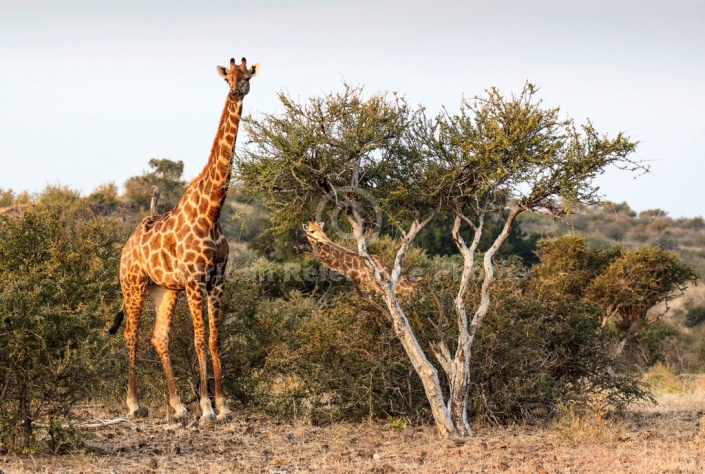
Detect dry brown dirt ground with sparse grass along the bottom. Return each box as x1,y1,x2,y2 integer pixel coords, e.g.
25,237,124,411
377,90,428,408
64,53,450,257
0,389,705,474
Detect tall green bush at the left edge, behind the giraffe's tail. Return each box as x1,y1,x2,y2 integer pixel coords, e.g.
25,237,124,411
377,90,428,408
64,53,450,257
0,203,120,451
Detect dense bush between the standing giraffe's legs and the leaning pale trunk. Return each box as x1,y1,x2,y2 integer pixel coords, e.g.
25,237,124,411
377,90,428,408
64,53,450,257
212,257,425,423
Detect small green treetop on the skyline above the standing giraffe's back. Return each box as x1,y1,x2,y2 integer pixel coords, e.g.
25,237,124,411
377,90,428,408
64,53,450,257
124,158,187,213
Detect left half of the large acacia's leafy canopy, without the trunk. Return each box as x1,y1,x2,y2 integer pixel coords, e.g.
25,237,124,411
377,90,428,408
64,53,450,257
237,85,429,235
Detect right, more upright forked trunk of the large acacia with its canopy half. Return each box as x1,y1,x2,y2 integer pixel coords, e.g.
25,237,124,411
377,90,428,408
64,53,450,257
418,84,643,435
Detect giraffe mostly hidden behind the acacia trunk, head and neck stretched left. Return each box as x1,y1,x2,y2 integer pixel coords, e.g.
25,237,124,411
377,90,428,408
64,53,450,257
304,221,414,296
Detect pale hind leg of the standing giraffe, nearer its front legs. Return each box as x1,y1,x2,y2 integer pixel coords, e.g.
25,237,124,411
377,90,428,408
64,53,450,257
149,286,188,419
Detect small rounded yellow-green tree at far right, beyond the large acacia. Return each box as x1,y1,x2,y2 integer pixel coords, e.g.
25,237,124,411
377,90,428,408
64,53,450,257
532,235,699,354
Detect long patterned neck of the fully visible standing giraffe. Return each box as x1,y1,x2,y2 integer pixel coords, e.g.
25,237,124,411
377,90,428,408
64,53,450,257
179,98,242,226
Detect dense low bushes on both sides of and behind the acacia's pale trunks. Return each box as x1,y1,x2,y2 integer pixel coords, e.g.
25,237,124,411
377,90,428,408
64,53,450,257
209,254,648,423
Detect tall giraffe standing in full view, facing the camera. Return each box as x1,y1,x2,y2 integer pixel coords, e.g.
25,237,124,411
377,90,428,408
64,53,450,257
109,58,259,422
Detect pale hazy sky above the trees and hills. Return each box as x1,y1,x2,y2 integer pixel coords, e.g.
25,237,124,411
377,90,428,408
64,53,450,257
0,0,705,217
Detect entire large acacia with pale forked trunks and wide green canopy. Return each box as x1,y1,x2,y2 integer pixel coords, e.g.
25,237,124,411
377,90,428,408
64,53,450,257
238,85,638,436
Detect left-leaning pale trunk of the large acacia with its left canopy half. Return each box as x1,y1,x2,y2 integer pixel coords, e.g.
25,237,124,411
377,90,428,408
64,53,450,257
237,85,458,435
